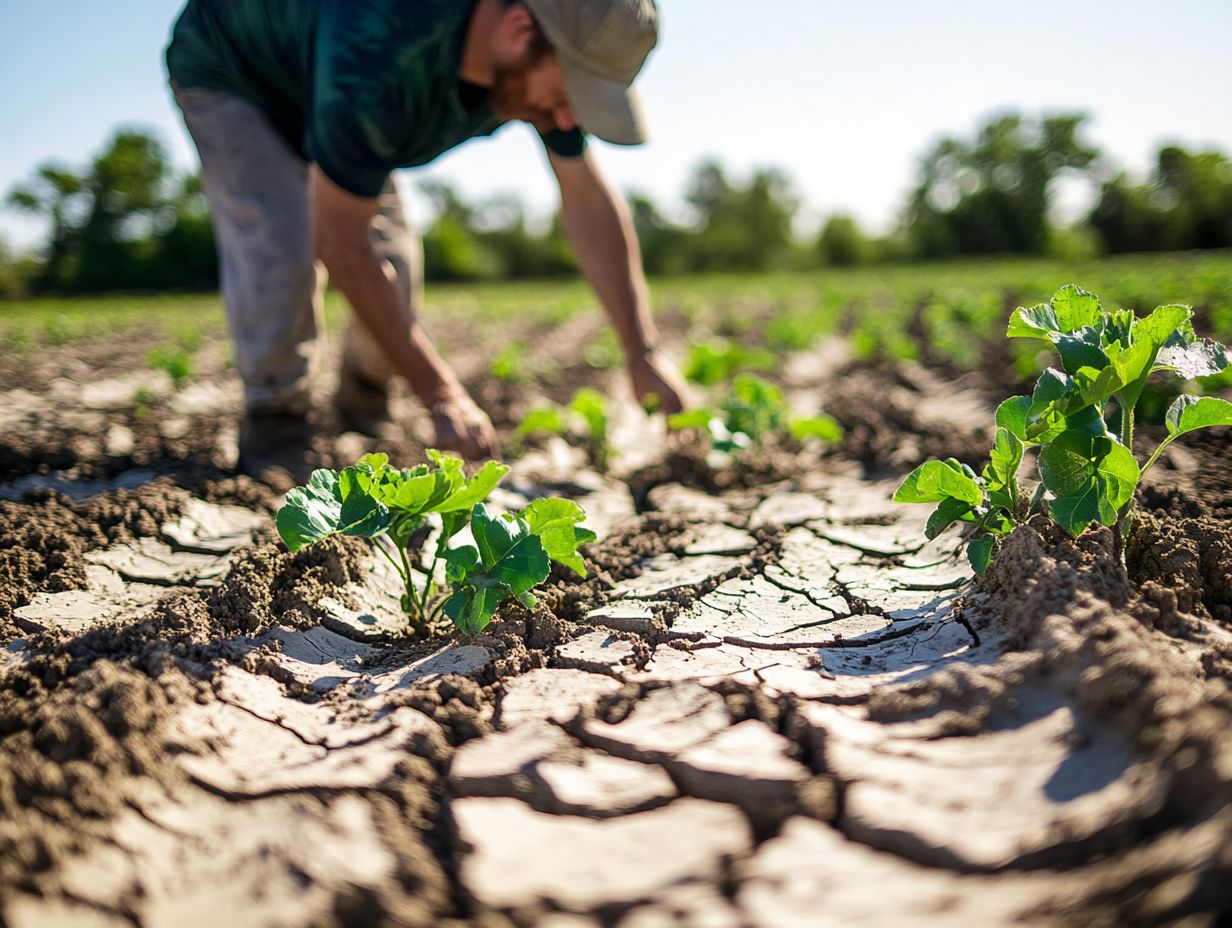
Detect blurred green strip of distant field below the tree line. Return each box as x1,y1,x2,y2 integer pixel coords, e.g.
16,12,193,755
0,251,1232,384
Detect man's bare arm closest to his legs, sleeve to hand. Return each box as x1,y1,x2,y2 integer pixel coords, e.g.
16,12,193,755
308,165,495,457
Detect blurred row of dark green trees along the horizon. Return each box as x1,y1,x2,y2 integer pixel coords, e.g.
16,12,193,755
0,113,1232,297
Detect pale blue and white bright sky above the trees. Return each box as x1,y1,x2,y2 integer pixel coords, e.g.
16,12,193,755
0,0,1232,243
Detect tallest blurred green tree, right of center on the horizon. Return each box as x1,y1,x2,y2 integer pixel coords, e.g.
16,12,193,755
906,113,1099,258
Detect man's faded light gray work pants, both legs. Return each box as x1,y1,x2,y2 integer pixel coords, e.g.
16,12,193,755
174,88,424,413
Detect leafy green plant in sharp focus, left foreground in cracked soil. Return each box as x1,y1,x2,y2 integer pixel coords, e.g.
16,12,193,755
277,451,595,635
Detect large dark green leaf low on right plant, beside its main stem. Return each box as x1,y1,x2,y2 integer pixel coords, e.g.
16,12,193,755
1040,431,1140,536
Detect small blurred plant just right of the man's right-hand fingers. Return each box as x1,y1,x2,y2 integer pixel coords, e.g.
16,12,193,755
668,373,843,466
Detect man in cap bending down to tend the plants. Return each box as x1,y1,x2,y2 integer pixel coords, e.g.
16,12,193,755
166,0,684,477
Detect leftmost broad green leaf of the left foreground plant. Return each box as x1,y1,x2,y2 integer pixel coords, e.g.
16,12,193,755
277,467,392,551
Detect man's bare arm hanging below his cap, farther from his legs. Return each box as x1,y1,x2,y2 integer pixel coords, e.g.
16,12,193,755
548,152,686,414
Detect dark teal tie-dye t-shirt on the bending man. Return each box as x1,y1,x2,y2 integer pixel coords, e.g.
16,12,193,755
166,0,585,197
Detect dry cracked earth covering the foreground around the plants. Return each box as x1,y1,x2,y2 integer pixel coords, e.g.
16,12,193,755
0,330,1232,928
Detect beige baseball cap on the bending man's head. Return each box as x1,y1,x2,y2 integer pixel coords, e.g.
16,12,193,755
522,0,659,145
